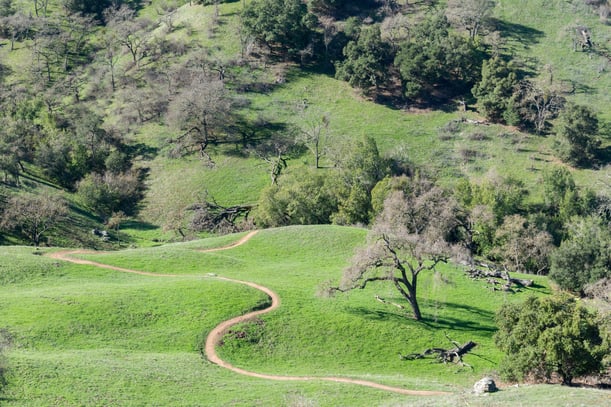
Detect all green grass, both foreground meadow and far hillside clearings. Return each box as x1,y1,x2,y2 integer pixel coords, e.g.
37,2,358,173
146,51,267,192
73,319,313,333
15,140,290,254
0,0,611,407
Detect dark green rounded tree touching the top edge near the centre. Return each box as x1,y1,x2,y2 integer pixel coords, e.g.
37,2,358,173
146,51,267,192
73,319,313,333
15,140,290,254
242,0,311,58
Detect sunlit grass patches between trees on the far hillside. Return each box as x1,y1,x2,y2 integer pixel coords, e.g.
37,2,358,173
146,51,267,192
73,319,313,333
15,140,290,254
0,0,611,246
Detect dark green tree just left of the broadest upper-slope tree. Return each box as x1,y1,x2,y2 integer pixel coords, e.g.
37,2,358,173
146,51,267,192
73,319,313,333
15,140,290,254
335,25,392,93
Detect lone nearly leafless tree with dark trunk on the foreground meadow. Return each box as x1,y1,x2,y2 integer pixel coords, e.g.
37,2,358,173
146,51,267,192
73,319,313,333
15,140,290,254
332,179,466,320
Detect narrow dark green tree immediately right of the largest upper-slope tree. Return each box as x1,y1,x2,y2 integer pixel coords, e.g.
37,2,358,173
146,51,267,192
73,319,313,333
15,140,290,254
471,56,518,124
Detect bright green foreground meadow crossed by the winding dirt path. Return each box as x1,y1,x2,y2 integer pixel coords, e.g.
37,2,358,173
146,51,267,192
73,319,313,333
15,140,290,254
0,227,609,406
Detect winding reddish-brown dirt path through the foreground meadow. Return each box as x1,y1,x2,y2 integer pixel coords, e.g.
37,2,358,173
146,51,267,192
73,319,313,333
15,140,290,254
48,230,451,396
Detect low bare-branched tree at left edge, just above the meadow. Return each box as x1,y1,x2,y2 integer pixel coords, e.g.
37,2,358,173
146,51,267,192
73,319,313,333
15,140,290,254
0,194,68,247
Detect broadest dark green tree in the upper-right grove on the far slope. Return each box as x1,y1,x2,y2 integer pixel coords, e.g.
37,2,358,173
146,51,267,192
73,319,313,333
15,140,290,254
395,14,482,98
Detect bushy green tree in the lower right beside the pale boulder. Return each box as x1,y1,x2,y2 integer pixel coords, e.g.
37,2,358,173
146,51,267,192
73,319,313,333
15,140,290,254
495,296,610,384
